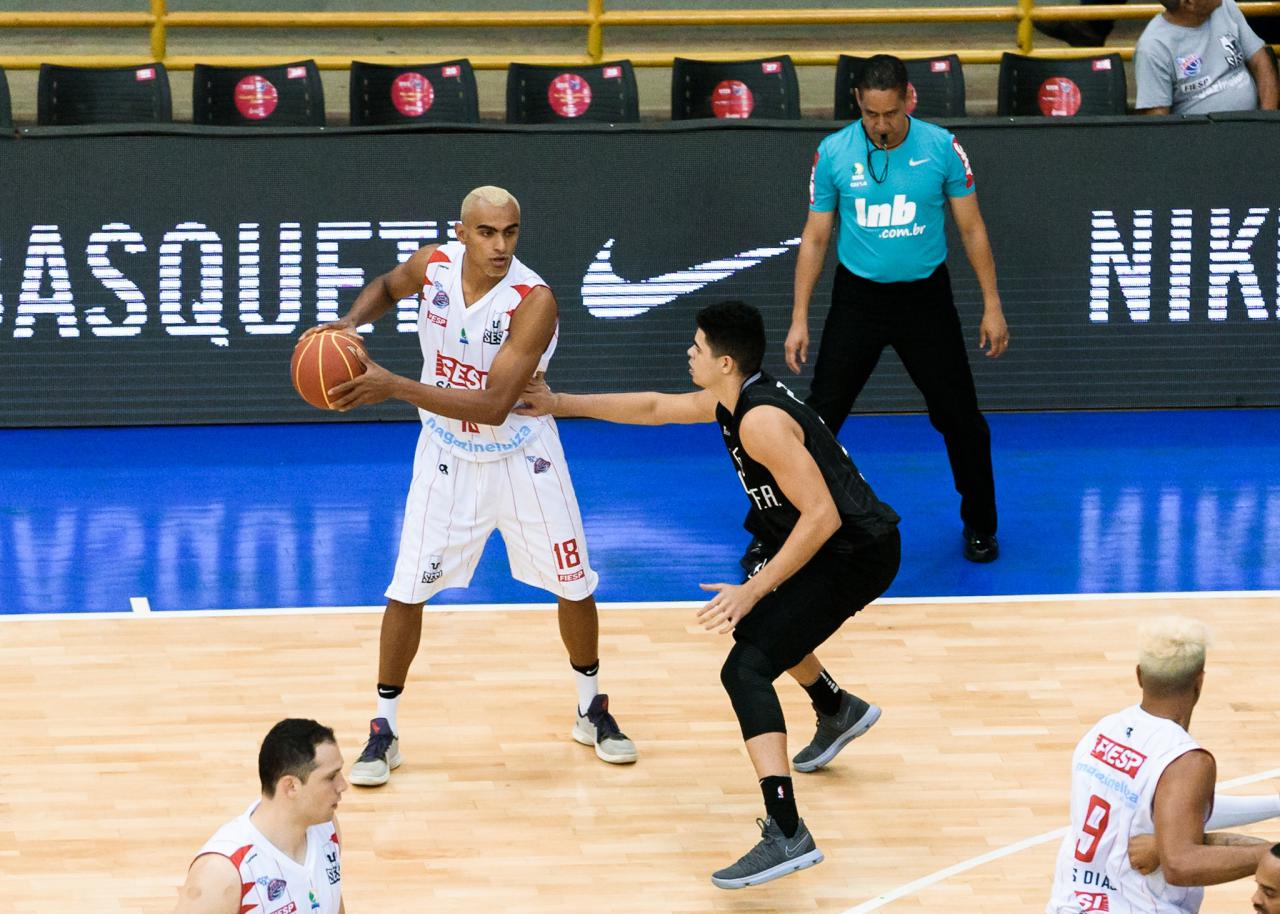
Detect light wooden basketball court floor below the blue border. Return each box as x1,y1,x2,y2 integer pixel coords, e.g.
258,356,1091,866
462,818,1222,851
0,594,1280,914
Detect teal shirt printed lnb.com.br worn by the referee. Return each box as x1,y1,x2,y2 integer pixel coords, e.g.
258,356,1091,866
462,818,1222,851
809,118,974,283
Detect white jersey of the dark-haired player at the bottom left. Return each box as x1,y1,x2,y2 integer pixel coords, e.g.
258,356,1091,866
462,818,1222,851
196,800,342,914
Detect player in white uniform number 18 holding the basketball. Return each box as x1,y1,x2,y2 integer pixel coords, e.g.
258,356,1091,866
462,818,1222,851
308,187,636,786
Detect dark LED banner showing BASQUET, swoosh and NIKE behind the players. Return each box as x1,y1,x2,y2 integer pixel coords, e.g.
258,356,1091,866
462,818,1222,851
0,114,1280,426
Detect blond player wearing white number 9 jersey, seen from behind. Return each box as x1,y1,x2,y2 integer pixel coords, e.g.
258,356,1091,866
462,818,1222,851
1046,617,1267,914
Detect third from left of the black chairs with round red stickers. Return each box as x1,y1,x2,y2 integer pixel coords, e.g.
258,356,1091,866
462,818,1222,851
507,60,640,124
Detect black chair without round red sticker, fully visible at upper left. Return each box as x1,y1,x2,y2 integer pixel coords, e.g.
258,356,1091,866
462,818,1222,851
36,64,173,127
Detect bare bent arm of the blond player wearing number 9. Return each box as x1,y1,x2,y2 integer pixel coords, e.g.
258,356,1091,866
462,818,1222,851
1152,750,1267,886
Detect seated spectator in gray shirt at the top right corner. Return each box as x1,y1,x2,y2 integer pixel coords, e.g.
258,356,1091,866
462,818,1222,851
1134,0,1277,114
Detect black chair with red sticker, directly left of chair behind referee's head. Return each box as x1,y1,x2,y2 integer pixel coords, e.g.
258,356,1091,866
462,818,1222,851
671,55,800,120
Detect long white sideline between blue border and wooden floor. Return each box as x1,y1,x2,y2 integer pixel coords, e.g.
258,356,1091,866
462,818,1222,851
0,590,1280,622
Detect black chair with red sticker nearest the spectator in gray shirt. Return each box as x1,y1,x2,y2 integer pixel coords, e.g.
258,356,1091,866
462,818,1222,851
996,54,1125,118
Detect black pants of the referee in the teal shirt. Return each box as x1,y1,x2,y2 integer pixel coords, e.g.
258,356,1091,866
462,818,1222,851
806,264,996,535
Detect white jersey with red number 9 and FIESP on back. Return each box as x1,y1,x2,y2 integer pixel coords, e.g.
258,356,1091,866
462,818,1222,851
1044,704,1211,914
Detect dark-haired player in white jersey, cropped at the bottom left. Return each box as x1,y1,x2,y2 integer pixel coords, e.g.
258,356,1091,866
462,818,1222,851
175,718,347,914
